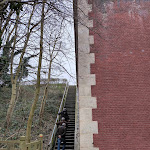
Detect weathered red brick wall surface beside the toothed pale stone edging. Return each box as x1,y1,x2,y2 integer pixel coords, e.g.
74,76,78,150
89,0,150,150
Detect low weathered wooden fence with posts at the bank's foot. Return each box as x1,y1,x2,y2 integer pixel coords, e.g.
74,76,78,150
0,134,43,150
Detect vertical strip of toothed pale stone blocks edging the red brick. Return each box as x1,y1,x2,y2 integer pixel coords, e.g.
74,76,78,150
78,0,98,150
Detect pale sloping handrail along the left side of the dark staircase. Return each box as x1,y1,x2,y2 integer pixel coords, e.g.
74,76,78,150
47,82,69,150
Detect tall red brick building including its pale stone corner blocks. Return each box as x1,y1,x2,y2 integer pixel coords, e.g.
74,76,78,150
74,0,150,150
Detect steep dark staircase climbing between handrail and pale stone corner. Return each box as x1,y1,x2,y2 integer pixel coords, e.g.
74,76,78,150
55,86,76,150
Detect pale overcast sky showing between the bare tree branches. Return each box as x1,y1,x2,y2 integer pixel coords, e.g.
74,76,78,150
0,1,76,85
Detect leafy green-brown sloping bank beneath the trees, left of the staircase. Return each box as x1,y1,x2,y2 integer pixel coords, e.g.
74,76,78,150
0,84,65,149
